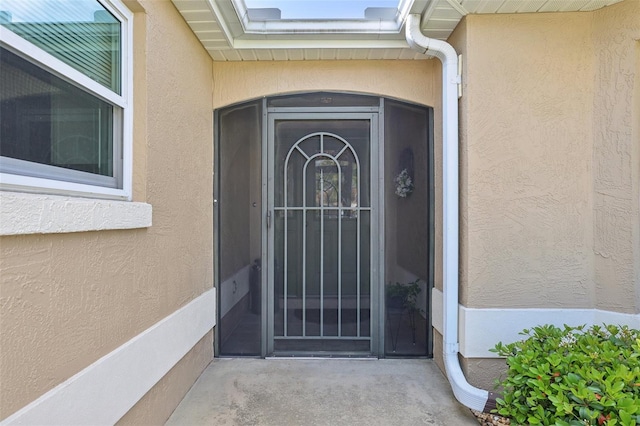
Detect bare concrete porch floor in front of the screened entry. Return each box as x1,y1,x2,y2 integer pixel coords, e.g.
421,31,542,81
166,358,478,426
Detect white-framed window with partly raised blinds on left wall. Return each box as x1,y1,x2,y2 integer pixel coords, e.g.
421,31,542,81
0,0,132,199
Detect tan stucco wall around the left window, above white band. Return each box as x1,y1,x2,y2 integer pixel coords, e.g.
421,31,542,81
0,0,213,420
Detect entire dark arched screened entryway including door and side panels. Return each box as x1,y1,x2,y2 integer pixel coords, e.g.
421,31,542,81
215,92,433,357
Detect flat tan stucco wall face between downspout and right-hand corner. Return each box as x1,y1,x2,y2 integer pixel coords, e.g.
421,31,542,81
461,10,593,308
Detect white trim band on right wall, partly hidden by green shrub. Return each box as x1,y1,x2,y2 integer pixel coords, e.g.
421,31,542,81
431,288,640,358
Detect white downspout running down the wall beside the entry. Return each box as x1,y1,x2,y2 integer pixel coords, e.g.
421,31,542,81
406,14,495,411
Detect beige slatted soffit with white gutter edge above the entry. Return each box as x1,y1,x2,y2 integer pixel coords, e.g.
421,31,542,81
172,0,622,61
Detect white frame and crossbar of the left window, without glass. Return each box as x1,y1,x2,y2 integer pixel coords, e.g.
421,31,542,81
0,0,133,201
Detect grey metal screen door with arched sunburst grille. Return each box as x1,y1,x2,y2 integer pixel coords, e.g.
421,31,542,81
267,113,378,355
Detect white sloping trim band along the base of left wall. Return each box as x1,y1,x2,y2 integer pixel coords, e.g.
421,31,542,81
0,289,216,426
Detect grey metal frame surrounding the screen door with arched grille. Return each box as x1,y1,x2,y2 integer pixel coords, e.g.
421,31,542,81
261,110,385,357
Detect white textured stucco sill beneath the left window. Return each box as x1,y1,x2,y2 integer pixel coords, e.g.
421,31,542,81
0,191,152,235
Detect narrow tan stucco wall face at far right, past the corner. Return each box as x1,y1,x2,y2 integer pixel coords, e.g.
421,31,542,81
592,0,640,313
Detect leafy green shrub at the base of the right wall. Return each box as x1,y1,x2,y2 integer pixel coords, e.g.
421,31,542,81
492,325,640,426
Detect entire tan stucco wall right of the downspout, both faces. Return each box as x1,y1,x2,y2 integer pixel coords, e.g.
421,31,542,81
452,1,640,313
